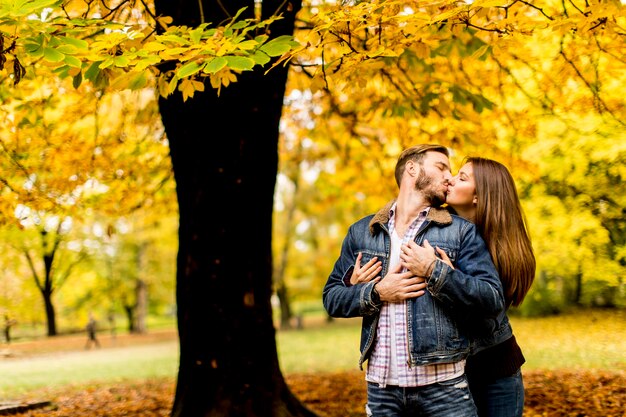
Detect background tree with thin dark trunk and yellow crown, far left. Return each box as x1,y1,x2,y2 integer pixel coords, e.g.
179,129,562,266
0,70,172,336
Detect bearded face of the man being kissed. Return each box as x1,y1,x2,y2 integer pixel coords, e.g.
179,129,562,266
415,151,452,207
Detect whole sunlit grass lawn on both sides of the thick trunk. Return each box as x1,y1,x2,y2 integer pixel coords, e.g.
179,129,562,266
0,311,626,399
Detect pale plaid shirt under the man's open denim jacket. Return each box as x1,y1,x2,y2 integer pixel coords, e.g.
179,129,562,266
365,204,465,388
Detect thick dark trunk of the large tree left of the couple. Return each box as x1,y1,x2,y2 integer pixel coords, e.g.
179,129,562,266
155,0,314,417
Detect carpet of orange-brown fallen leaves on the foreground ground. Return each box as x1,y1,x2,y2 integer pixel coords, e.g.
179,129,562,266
9,371,626,417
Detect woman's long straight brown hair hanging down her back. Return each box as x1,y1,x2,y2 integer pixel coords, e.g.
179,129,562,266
465,157,536,306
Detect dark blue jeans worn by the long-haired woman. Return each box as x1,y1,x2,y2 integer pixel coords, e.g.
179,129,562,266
470,369,524,417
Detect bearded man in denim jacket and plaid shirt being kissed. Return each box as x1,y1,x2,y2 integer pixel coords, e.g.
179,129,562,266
323,145,504,417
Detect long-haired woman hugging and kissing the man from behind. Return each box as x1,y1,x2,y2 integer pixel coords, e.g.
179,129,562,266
351,157,535,417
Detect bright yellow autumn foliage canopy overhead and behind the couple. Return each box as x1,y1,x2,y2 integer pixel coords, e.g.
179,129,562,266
0,0,626,322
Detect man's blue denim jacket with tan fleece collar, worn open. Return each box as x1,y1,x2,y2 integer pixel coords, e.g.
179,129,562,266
323,202,512,368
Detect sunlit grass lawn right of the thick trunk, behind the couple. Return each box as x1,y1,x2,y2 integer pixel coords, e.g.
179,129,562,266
278,310,626,373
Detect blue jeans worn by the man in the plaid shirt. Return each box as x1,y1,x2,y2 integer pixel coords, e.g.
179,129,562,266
366,375,477,417
